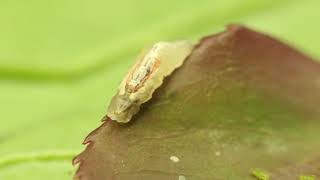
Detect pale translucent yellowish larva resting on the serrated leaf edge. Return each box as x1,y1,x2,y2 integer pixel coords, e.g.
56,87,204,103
107,41,193,123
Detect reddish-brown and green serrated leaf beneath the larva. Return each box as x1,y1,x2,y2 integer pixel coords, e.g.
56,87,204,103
74,26,320,180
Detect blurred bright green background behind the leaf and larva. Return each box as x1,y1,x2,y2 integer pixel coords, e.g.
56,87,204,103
0,0,320,180
